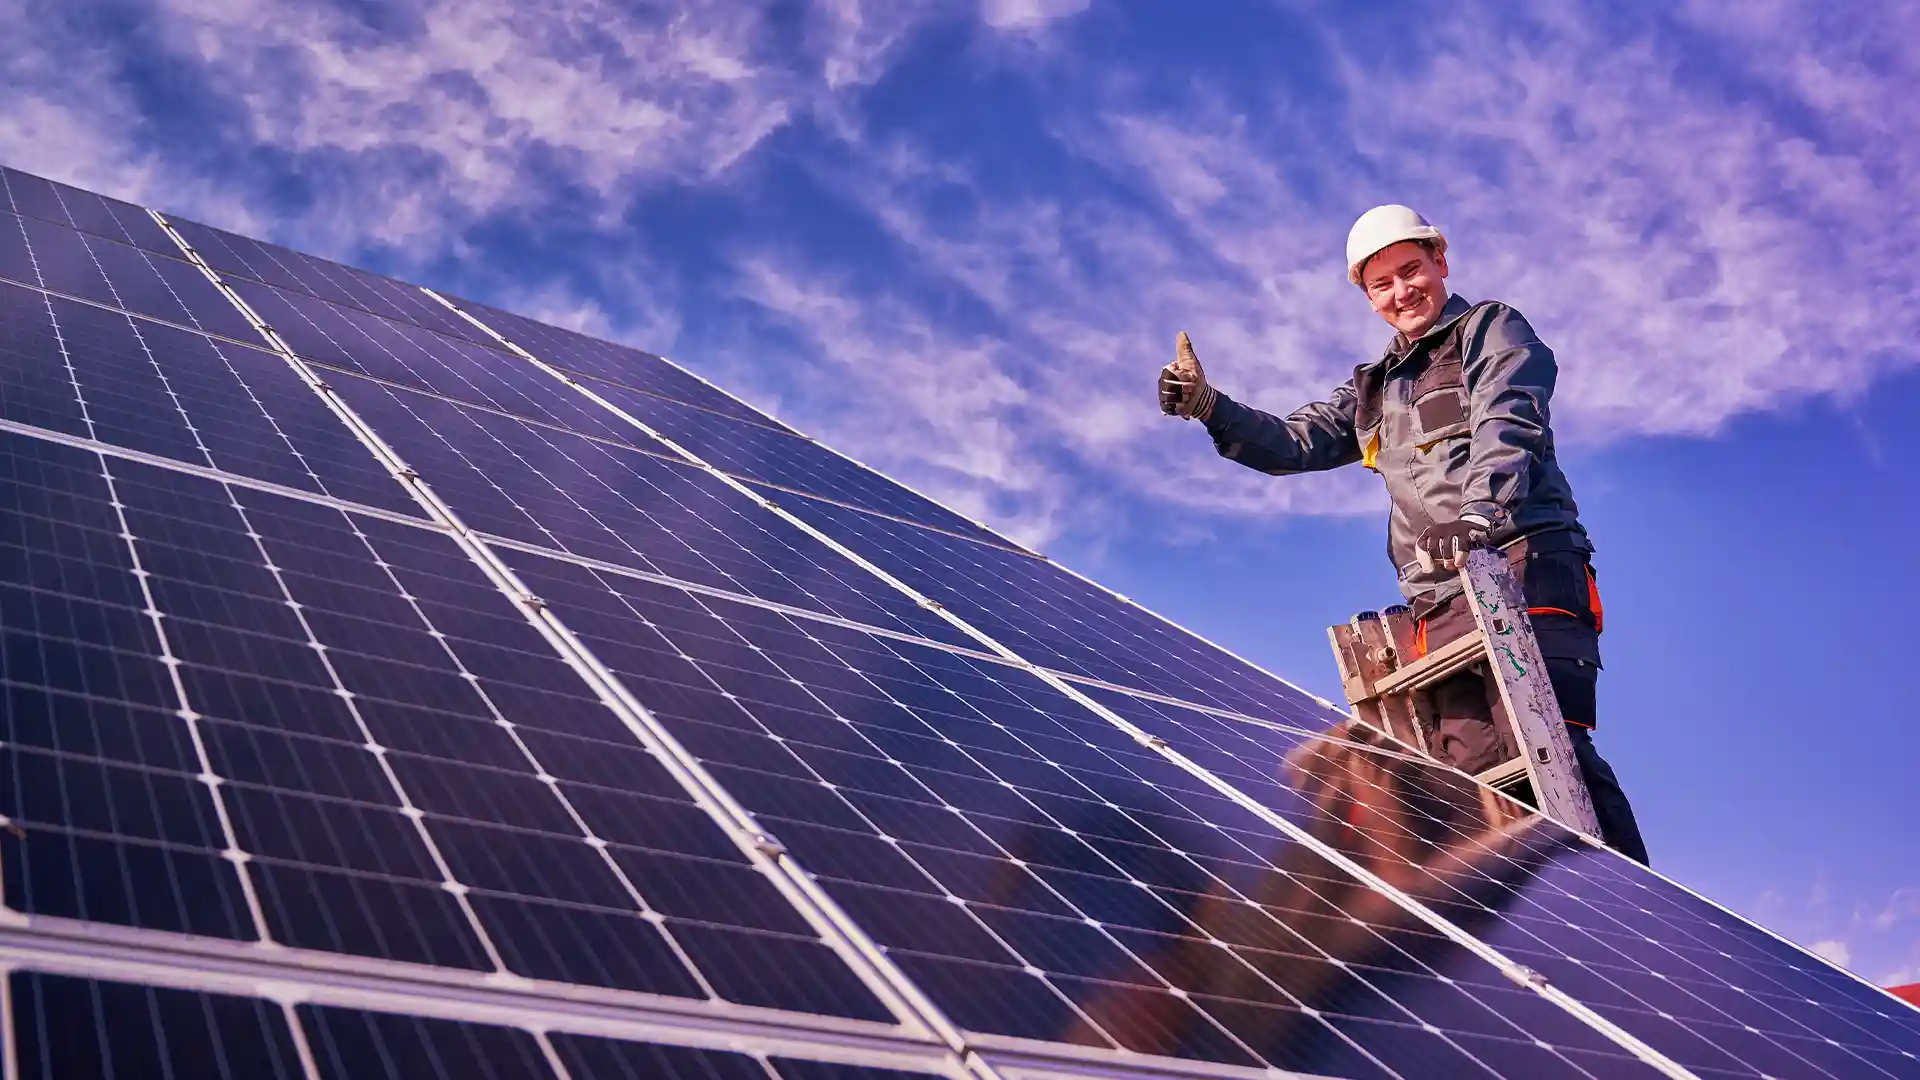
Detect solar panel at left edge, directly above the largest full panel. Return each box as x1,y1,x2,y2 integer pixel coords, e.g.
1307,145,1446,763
0,282,420,515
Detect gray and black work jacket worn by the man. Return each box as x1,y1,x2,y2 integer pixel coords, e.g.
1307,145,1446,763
1206,296,1594,613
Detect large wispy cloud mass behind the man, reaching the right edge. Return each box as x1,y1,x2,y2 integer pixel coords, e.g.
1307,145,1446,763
721,4,1920,538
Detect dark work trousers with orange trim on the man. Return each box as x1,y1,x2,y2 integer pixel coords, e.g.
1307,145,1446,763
1427,552,1647,863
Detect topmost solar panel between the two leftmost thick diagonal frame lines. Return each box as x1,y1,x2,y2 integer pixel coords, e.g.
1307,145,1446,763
171,217,492,344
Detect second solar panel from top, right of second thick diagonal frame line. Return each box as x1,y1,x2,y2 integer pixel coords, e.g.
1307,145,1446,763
568,382,1012,548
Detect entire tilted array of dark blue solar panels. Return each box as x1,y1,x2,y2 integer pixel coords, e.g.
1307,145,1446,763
0,161,1920,1080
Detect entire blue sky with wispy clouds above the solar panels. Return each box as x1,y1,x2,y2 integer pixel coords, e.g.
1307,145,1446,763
0,0,1920,982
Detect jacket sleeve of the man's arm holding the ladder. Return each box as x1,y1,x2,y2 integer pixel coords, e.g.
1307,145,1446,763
1459,304,1559,532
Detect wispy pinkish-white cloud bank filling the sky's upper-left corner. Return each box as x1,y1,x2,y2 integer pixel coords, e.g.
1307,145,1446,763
0,0,1006,261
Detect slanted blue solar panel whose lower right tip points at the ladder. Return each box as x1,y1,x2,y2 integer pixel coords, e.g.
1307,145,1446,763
764,500,1340,718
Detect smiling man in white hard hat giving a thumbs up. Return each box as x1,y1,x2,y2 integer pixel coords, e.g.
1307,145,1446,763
1160,206,1647,863
